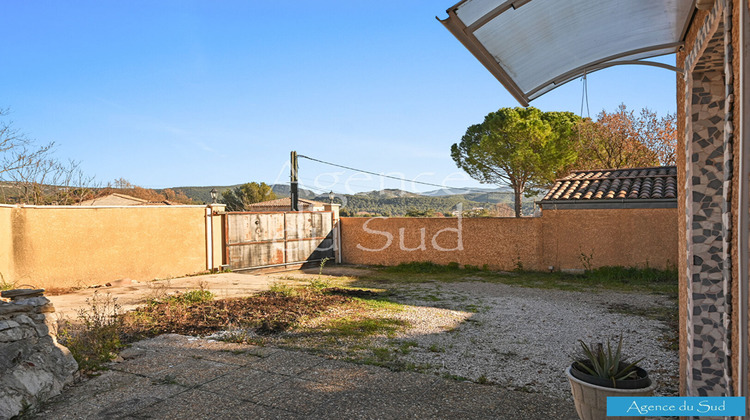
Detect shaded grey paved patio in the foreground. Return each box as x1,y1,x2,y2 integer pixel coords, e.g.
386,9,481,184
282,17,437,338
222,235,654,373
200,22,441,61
37,334,577,420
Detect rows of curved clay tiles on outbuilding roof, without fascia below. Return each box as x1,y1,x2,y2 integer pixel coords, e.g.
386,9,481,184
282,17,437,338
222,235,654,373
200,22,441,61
542,166,677,201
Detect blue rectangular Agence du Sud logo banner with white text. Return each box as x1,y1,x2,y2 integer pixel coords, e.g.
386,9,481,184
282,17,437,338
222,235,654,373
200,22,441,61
607,397,745,417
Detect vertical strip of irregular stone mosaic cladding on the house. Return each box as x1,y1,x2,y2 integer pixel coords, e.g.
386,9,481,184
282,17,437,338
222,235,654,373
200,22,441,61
685,0,733,402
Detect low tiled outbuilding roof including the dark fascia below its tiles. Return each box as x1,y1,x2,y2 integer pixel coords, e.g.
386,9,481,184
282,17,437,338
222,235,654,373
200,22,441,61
539,166,677,208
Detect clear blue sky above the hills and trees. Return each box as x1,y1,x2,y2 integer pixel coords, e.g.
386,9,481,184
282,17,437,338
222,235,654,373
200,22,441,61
0,0,676,192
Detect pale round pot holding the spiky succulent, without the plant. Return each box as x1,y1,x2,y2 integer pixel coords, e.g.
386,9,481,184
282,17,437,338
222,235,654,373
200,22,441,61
565,366,656,420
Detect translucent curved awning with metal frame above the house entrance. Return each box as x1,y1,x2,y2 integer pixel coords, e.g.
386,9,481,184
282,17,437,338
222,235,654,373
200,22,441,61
441,0,695,106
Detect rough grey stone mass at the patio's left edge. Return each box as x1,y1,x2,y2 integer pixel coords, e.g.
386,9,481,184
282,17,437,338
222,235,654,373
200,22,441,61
0,290,78,420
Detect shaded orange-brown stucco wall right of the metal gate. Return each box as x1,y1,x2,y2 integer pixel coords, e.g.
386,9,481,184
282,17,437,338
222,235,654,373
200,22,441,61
341,209,677,270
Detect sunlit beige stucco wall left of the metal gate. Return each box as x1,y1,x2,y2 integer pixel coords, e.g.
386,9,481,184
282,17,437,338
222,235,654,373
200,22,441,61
6,206,222,288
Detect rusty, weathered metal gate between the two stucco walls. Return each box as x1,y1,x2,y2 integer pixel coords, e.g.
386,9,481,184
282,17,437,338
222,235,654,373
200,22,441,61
224,211,334,270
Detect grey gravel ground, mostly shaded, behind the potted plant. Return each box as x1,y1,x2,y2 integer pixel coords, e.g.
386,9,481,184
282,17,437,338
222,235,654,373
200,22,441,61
376,282,678,399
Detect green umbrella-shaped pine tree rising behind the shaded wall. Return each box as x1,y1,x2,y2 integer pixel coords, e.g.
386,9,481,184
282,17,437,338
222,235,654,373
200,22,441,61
451,107,580,217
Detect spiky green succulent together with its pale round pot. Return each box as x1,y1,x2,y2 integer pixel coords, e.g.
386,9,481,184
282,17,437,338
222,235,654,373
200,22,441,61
565,336,656,420
